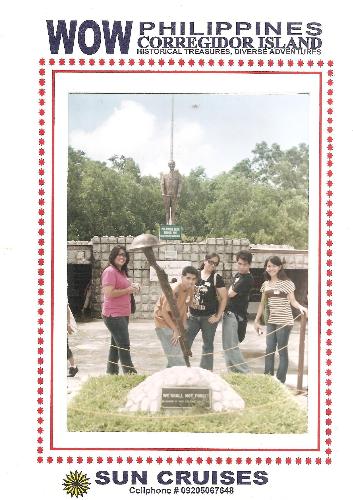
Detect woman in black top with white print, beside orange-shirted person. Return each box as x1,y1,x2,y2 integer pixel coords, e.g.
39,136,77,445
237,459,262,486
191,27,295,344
187,253,227,370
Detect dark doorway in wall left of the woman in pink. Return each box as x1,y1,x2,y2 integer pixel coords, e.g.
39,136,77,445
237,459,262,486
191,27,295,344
67,264,92,319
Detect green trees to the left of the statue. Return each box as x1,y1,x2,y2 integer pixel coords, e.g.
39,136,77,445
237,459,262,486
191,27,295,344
68,148,163,240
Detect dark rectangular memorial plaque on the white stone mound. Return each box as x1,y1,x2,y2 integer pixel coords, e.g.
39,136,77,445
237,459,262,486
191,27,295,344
161,387,211,409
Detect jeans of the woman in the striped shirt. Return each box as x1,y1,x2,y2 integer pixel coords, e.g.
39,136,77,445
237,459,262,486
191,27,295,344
265,323,292,384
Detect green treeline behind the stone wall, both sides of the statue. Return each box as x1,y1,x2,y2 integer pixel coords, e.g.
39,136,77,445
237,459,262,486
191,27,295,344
68,142,309,248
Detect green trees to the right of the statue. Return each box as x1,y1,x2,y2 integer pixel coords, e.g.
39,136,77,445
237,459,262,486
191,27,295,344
206,142,308,248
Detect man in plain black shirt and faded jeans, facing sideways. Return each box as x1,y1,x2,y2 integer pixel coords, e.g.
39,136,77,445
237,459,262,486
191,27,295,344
222,250,254,373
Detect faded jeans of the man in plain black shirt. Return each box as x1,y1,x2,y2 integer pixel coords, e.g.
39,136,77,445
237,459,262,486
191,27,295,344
222,311,250,373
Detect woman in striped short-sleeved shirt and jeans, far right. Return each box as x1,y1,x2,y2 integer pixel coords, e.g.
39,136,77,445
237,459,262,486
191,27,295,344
255,255,307,383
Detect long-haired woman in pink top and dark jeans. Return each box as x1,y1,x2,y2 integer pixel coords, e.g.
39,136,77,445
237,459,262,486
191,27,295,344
102,245,139,375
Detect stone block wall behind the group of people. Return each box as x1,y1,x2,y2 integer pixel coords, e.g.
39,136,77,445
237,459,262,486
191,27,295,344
67,236,308,319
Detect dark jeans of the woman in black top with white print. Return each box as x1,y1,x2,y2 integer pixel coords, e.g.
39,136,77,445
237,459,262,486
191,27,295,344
187,315,218,370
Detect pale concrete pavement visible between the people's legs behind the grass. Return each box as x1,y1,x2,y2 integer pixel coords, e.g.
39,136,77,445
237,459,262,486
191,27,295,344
67,320,307,407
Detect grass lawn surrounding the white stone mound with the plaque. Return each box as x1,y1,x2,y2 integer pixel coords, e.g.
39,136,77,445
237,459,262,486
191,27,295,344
67,374,307,434
